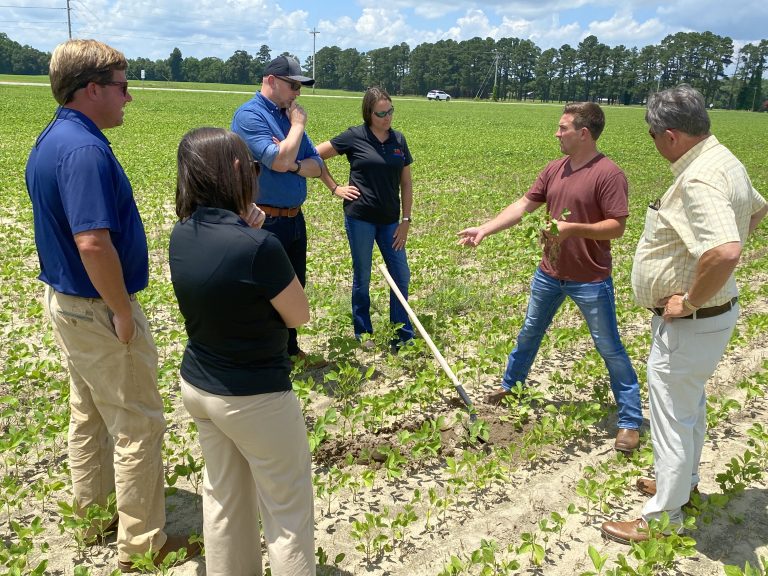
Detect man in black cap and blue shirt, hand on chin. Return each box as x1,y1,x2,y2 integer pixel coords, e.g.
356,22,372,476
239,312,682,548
232,56,325,367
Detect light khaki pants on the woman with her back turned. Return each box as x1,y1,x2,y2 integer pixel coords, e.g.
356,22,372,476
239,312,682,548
181,380,315,576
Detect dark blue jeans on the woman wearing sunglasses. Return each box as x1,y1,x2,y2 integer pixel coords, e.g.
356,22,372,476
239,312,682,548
344,216,413,342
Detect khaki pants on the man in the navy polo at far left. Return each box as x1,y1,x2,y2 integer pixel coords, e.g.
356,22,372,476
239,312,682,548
45,286,166,561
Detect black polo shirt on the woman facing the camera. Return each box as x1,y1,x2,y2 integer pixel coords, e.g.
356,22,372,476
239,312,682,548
331,124,413,224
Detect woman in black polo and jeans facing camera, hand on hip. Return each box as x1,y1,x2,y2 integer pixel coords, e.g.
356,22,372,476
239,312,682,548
317,87,413,351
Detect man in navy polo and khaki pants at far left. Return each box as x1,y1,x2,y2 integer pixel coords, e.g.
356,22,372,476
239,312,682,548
26,40,200,572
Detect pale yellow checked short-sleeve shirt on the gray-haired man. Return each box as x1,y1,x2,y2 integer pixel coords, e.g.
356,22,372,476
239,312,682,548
632,136,765,308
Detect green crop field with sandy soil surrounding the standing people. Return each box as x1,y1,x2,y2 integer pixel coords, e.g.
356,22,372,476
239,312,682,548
0,82,768,576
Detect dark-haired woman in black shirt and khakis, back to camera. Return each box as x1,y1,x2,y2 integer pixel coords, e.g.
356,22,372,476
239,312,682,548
170,128,315,576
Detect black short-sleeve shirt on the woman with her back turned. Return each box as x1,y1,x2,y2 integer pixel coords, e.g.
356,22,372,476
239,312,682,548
169,207,296,396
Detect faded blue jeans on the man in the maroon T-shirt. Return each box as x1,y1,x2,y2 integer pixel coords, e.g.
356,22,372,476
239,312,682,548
502,268,643,429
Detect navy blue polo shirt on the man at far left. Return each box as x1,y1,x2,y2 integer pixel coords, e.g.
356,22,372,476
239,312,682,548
26,108,149,298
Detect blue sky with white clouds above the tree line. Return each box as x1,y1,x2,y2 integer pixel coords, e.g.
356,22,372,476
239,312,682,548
6,0,768,62
